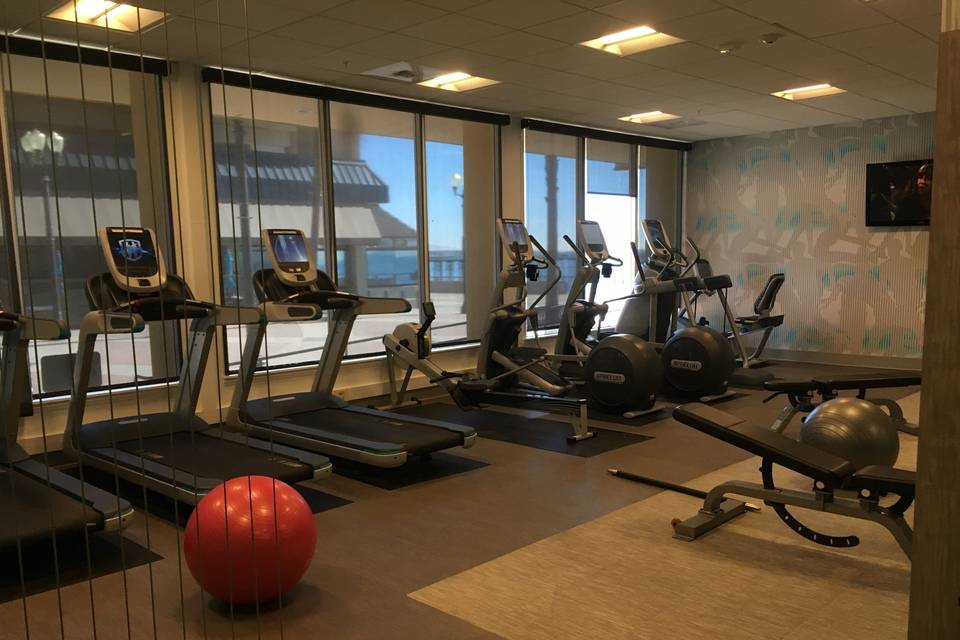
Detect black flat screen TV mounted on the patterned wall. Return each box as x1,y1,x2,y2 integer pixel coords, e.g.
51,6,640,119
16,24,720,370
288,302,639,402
867,160,933,227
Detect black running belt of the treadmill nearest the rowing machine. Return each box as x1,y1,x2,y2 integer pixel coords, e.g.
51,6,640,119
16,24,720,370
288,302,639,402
271,409,463,455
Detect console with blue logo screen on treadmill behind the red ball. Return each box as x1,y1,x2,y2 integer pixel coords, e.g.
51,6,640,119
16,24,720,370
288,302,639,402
97,227,167,293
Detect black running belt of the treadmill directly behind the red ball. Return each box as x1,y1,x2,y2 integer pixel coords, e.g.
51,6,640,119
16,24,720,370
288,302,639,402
117,431,313,484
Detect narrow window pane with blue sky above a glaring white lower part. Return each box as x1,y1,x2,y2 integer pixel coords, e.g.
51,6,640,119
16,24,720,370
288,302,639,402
584,139,637,325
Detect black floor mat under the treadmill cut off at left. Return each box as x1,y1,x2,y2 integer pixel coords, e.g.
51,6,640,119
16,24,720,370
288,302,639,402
0,532,163,604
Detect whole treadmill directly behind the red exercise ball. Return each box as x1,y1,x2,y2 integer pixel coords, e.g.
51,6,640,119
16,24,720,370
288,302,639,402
63,227,331,504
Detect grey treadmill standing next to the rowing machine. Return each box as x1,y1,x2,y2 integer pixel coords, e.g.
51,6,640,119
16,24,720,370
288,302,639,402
228,229,477,467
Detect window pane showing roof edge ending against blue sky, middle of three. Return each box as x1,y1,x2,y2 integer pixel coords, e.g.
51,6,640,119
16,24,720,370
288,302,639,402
330,102,420,355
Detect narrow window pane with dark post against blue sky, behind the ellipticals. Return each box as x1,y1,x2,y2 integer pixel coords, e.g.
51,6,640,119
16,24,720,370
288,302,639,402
524,130,578,327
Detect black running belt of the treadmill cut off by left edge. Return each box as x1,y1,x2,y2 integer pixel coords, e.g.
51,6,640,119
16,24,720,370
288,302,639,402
0,471,103,549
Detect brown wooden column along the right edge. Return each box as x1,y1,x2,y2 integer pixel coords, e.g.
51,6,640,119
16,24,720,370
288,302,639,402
910,0,960,640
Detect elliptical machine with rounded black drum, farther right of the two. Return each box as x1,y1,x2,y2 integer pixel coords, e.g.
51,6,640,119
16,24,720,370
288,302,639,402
610,219,736,402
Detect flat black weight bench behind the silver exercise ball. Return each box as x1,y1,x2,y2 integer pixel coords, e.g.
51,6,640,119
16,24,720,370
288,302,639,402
763,371,920,436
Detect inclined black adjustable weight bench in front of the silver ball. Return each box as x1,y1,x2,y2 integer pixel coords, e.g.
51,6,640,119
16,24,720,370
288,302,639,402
673,402,915,558
